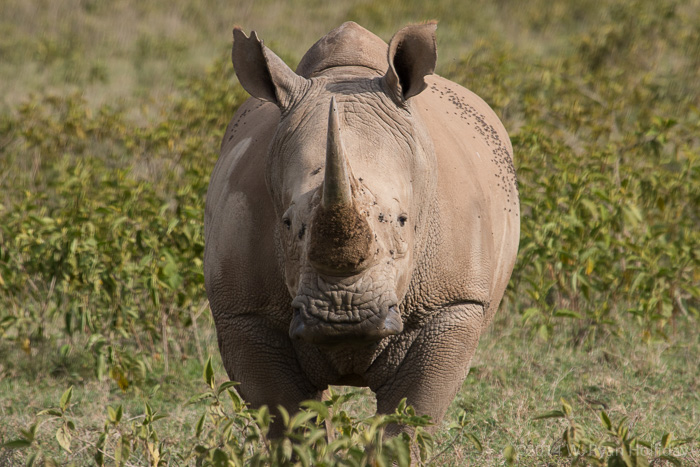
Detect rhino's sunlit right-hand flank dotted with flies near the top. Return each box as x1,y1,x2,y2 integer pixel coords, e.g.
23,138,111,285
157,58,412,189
414,75,520,326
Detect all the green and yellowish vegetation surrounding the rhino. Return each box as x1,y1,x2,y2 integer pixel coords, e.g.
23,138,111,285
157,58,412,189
0,0,700,466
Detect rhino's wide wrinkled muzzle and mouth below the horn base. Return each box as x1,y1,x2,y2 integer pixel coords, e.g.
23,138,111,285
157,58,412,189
289,277,403,345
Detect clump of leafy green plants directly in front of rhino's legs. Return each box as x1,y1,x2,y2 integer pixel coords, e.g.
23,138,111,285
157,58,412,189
184,359,433,466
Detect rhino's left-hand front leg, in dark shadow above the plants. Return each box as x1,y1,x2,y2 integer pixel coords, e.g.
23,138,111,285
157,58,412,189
216,315,321,438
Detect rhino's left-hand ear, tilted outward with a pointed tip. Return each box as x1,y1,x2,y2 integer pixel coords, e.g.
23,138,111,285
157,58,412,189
231,27,308,113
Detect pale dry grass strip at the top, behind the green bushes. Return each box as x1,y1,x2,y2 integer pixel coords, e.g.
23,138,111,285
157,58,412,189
0,0,700,111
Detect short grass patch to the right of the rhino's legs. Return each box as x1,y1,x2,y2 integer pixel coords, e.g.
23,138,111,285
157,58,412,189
446,310,700,465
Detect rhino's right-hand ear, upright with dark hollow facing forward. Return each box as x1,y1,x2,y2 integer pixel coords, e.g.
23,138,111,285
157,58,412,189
384,21,437,104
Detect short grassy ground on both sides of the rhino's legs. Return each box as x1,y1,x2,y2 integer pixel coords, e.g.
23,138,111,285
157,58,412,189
0,313,700,466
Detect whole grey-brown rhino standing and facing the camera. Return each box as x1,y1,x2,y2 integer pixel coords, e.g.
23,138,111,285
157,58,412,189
204,23,520,434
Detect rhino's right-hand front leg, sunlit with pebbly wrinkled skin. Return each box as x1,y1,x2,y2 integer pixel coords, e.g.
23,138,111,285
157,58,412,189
375,303,484,434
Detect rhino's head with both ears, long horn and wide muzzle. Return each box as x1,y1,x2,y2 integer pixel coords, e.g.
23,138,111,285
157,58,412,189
233,24,437,344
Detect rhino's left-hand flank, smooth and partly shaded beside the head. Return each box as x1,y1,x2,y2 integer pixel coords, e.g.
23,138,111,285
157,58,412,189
204,98,290,327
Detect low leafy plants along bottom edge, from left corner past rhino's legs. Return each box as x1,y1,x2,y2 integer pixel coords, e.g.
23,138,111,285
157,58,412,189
2,358,438,467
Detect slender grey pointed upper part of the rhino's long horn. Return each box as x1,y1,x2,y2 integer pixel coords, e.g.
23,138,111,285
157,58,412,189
322,97,352,208
